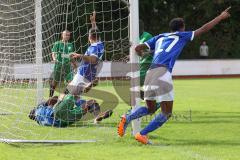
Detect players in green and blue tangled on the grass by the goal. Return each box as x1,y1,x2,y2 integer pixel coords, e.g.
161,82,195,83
29,94,112,127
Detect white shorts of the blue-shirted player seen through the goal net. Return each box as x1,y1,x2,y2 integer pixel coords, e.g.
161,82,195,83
67,73,91,95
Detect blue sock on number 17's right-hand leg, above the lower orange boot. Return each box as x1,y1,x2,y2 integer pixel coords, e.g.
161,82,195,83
140,113,167,135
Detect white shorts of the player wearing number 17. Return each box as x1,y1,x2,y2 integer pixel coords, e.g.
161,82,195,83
143,67,174,102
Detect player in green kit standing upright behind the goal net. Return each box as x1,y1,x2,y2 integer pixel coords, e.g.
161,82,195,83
49,30,74,97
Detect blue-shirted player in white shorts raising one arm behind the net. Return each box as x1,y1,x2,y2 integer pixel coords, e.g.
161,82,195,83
67,12,104,95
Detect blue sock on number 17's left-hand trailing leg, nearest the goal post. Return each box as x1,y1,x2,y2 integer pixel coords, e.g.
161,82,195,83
126,107,149,123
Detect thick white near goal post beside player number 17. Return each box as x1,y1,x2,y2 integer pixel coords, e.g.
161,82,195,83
129,0,141,135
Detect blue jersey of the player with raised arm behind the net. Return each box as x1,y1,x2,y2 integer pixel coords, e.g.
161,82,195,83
79,41,104,82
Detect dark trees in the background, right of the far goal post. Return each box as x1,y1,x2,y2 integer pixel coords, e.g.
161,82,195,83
42,0,240,62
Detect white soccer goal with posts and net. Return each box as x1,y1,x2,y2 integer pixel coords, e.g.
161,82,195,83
0,0,140,143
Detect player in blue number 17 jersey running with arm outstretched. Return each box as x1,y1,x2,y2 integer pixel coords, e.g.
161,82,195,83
118,8,230,144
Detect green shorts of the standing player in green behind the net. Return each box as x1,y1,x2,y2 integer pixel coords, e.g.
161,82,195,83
53,63,73,82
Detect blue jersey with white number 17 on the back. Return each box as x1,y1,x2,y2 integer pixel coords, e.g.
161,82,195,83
145,31,194,72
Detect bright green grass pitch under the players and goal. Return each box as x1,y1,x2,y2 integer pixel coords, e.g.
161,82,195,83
0,78,240,160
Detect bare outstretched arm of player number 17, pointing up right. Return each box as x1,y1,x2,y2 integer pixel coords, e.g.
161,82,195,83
194,7,231,37
